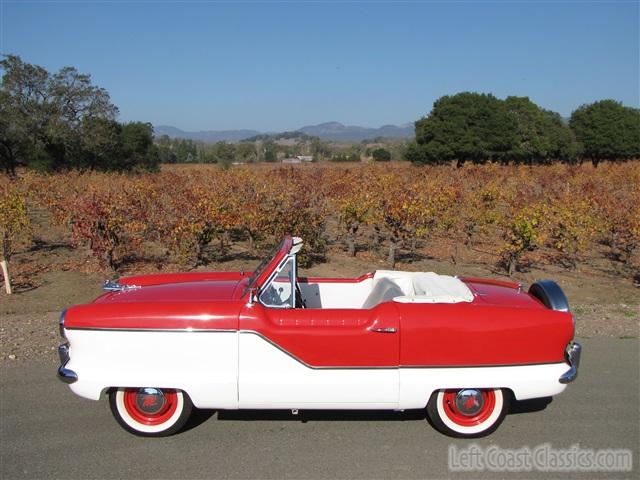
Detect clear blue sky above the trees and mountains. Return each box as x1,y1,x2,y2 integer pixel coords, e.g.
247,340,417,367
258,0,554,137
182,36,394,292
0,0,639,131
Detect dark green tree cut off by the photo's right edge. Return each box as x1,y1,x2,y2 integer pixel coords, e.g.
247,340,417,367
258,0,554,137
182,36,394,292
569,100,640,166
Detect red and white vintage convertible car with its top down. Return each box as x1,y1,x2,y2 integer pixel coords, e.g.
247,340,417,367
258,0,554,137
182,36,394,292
58,237,581,437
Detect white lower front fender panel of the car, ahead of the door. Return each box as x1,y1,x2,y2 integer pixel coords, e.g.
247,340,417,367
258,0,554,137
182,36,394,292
66,330,238,408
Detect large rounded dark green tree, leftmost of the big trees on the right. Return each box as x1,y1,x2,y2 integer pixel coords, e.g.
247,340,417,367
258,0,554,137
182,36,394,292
407,92,517,166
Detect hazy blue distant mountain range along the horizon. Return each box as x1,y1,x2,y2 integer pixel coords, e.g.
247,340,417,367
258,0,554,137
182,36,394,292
154,122,414,143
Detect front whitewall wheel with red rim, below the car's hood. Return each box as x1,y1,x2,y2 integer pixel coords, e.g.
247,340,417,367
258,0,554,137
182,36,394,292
109,387,193,437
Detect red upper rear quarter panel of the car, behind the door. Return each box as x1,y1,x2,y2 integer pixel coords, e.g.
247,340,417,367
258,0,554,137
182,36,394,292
400,302,573,366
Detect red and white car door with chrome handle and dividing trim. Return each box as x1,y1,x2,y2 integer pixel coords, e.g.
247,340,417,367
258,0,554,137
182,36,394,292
238,258,400,409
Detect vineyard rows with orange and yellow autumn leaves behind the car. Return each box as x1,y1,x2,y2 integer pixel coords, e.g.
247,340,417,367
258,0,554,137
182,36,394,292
7,162,640,275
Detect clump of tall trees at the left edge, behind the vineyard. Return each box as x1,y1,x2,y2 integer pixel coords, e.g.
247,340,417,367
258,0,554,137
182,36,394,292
0,55,159,175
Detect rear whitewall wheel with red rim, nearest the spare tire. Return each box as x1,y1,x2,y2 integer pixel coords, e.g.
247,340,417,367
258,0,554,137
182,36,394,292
427,388,509,438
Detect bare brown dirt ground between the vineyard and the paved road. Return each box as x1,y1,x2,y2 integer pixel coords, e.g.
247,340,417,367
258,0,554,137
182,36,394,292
0,220,640,363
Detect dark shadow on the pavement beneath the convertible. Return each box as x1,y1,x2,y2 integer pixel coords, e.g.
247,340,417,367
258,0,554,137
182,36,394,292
185,397,552,430
